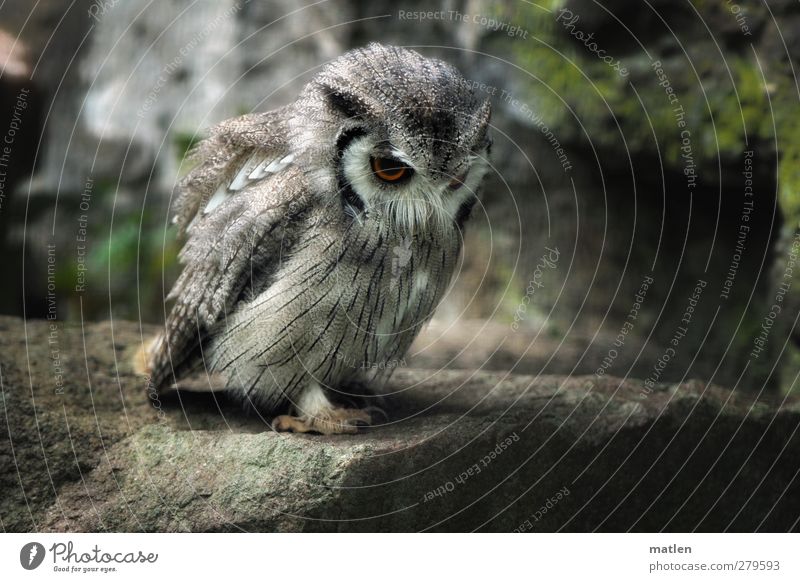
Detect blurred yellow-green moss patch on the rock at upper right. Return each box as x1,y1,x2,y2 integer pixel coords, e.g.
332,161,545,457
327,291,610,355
511,2,788,175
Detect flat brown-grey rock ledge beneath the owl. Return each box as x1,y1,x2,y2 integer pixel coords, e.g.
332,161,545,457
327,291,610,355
0,317,800,532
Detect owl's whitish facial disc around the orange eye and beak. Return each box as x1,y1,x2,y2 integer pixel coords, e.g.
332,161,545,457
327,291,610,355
339,132,485,232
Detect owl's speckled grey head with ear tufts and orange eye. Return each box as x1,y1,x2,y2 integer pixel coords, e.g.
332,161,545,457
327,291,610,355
293,44,491,232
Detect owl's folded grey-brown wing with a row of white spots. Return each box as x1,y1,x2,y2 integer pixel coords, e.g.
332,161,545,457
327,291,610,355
148,110,310,388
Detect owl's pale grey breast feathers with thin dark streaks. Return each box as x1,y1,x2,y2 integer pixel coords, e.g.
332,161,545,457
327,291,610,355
204,209,460,409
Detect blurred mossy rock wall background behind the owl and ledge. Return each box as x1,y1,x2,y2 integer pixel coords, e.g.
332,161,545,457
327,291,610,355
0,0,800,394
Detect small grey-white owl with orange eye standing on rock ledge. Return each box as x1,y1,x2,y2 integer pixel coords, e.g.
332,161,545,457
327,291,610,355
143,44,490,434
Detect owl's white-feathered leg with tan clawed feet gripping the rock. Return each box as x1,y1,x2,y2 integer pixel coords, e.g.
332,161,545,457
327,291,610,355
272,382,372,434
